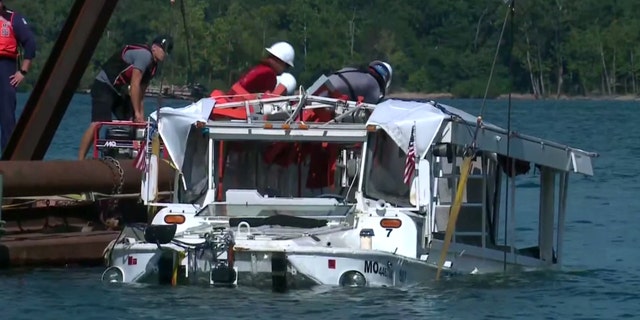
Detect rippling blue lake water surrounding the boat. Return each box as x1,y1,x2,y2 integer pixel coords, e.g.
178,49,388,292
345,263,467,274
0,95,640,320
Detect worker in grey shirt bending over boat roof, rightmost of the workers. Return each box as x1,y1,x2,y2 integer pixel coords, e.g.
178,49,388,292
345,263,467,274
314,60,393,104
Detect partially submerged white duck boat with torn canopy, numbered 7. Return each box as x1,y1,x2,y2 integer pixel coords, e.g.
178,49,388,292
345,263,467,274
102,86,596,290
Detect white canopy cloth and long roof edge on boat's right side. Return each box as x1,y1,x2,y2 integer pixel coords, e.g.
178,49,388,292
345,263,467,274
367,99,598,175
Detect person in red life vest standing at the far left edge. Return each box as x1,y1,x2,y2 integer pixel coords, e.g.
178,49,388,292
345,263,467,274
0,0,36,150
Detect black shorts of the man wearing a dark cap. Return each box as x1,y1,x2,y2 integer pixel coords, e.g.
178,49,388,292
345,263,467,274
91,80,133,122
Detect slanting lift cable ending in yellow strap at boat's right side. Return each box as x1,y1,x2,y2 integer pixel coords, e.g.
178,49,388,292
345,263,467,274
436,0,515,281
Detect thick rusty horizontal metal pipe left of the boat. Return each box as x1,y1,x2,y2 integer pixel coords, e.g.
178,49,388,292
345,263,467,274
0,160,175,197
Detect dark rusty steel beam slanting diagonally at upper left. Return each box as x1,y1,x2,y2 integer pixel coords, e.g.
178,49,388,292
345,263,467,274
2,0,118,160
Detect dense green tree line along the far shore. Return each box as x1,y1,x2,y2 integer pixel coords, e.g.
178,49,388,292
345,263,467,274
4,0,640,98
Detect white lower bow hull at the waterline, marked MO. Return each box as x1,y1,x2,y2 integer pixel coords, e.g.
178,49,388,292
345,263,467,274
103,243,450,288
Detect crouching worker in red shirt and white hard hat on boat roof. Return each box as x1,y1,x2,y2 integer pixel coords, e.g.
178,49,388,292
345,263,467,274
209,42,295,120
